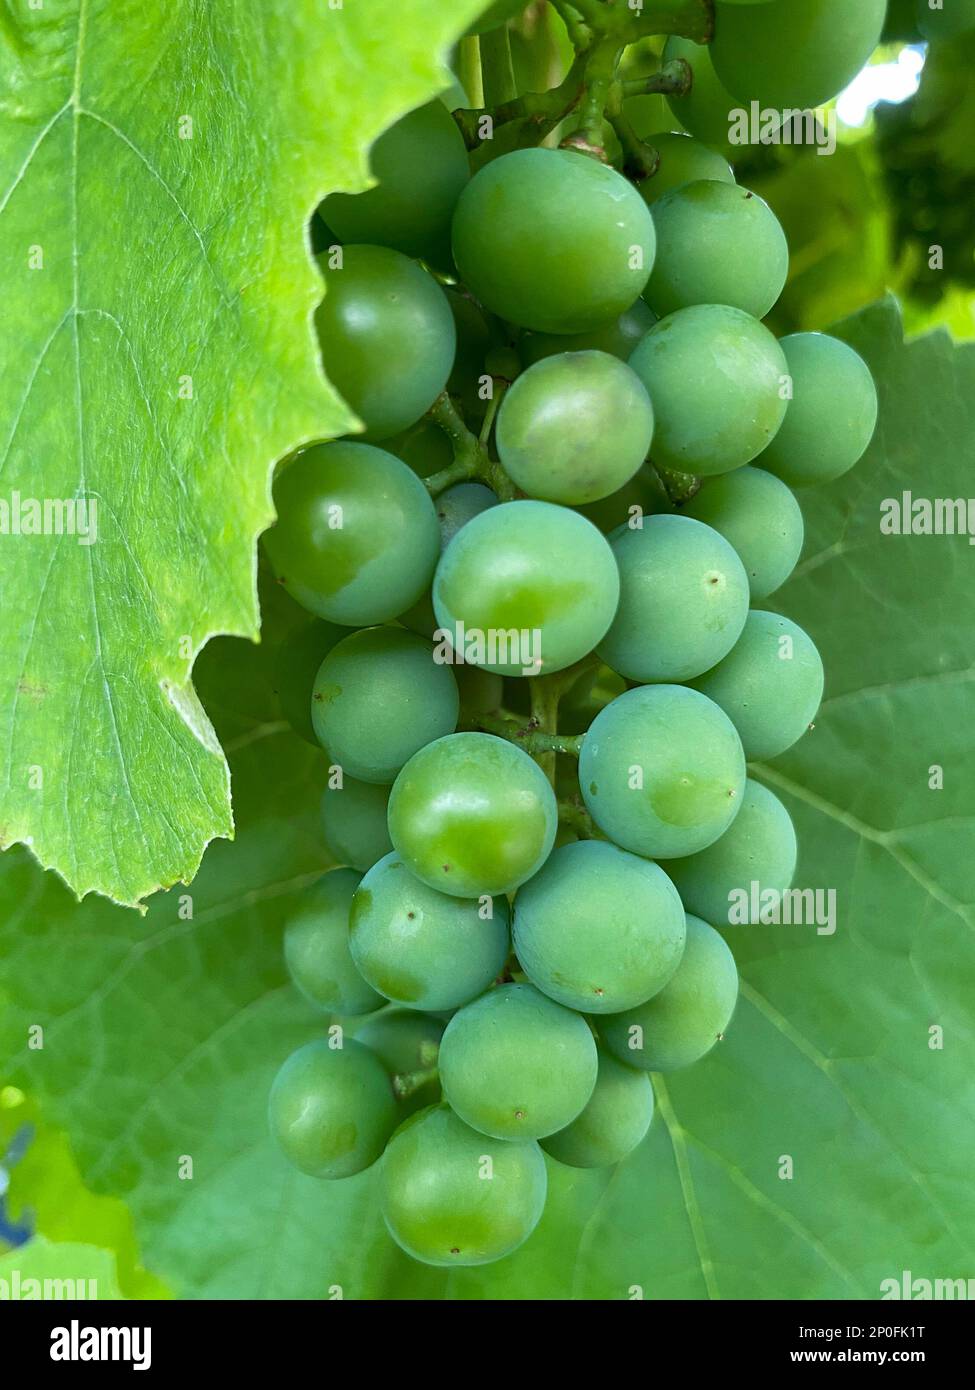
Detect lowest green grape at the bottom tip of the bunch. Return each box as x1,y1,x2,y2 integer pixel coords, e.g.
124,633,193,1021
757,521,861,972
380,1105,548,1268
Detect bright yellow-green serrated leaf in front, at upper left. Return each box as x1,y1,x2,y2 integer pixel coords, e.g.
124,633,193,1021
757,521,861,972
0,0,477,905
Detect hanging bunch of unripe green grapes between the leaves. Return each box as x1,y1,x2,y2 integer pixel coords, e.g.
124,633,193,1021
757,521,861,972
266,0,876,1266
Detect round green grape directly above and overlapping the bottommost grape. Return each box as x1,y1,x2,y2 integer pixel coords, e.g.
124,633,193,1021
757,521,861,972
440,984,597,1140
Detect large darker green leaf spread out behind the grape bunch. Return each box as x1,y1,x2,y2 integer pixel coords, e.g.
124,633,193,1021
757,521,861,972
0,302,975,1300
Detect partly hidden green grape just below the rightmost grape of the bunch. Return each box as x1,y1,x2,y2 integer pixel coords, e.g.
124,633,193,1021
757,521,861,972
682,467,804,602
